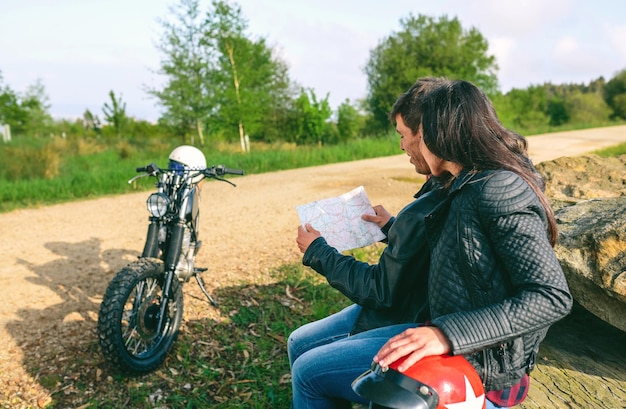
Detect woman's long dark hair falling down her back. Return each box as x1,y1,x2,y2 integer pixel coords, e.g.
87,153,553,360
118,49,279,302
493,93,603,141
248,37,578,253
422,80,558,246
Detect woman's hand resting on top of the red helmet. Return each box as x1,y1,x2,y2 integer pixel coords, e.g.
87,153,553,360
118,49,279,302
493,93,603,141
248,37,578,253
374,327,452,372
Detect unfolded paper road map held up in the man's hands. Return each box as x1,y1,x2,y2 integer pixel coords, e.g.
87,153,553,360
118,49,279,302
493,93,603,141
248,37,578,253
296,186,385,252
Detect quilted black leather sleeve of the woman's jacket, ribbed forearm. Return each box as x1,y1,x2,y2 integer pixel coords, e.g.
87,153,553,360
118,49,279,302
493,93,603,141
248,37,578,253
433,172,572,354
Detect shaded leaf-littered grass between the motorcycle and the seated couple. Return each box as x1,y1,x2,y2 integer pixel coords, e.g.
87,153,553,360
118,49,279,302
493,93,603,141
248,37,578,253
25,253,390,409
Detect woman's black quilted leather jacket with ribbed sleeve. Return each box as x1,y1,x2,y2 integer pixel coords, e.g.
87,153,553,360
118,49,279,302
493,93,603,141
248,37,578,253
426,170,572,391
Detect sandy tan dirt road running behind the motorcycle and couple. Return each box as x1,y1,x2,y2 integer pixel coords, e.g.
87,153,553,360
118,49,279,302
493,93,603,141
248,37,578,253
0,126,626,407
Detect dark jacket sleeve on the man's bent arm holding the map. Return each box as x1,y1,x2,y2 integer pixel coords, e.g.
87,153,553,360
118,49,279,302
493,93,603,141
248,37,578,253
302,184,443,309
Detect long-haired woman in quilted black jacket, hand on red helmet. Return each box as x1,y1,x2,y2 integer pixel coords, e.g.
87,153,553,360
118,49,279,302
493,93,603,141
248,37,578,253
374,81,572,407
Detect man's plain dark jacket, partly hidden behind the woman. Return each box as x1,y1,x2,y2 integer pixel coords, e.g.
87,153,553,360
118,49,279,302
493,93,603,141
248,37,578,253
302,180,446,334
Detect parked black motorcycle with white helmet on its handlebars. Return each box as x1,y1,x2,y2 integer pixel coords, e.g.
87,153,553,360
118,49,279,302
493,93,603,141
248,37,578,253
97,145,244,374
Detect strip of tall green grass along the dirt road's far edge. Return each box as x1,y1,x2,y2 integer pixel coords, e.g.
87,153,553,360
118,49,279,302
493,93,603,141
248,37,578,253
0,136,400,212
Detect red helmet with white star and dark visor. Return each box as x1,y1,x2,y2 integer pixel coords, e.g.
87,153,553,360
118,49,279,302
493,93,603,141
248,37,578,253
352,355,486,409
